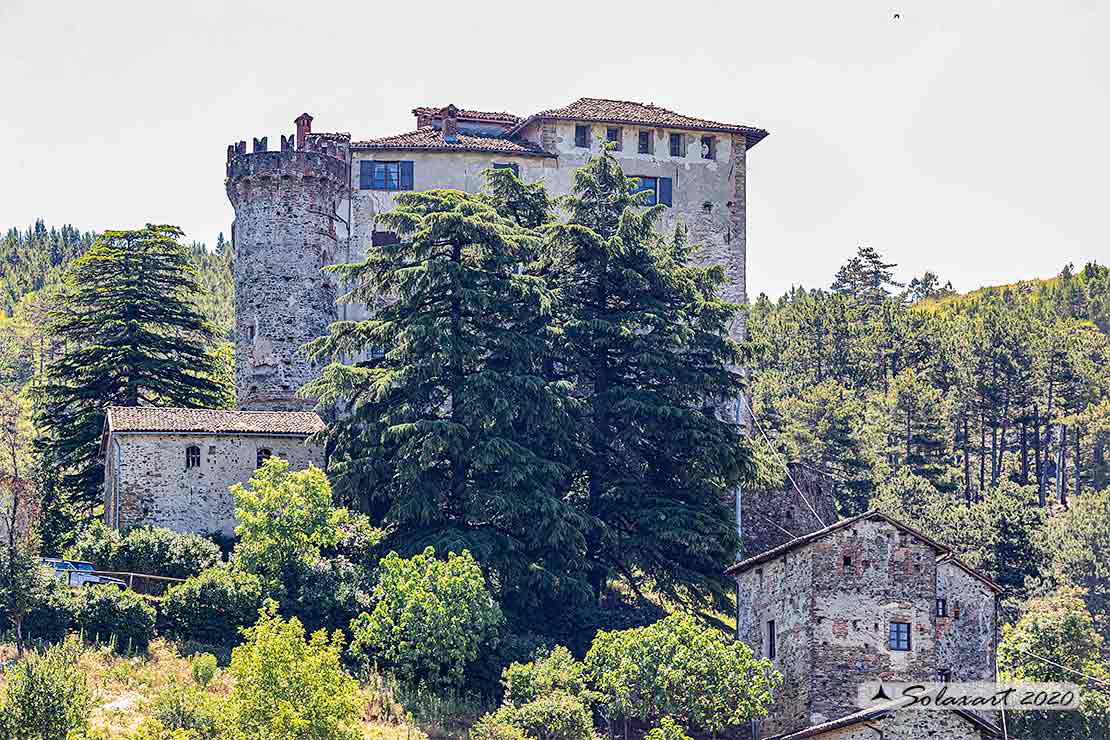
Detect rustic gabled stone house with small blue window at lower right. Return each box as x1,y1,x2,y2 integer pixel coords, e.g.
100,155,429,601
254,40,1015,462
728,511,1001,740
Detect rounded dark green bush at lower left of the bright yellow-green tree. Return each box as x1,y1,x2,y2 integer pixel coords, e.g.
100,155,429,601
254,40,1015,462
162,566,262,646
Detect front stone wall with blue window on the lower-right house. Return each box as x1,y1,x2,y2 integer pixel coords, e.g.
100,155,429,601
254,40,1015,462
807,519,937,724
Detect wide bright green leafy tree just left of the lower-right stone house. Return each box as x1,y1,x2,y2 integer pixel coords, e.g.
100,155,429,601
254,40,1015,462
585,614,781,737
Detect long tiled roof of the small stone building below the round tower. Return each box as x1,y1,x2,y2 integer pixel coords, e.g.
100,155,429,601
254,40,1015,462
104,406,324,436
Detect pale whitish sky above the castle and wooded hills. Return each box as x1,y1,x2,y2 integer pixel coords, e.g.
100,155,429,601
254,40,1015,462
0,0,1110,296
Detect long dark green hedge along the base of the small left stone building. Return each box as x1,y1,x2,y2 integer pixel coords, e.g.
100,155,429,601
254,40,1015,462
67,521,221,578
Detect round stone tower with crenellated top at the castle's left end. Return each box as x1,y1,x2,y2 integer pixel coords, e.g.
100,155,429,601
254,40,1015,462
226,113,350,410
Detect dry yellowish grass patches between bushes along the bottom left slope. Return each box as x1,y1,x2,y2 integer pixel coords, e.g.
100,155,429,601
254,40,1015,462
0,638,470,740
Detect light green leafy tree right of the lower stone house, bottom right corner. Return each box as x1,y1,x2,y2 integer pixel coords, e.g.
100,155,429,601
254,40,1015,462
998,587,1110,740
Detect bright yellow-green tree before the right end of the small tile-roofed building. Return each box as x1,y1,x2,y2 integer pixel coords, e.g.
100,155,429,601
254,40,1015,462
231,457,347,588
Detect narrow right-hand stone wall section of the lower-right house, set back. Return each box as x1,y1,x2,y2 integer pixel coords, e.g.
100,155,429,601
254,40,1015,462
937,560,997,681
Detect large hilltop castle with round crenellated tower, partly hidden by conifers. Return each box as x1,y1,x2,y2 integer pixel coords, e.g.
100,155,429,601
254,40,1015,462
220,98,767,414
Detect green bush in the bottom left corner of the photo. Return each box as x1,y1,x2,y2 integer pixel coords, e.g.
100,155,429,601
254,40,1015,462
0,640,90,740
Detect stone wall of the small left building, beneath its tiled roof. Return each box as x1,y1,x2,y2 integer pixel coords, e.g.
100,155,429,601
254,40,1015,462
104,433,323,535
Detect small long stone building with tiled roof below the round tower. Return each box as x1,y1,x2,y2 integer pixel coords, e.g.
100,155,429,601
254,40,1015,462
100,406,324,535
